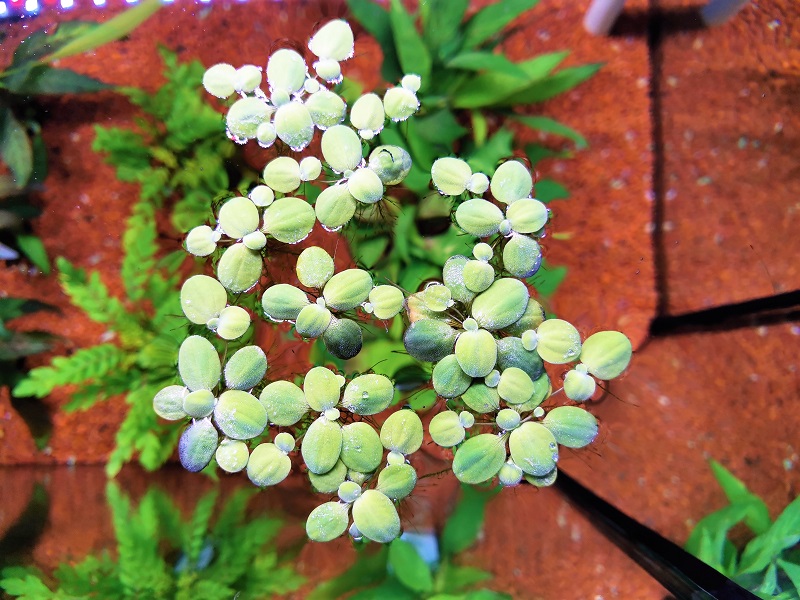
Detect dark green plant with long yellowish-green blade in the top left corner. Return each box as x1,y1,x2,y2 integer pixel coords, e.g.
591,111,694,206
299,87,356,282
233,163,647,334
0,0,160,273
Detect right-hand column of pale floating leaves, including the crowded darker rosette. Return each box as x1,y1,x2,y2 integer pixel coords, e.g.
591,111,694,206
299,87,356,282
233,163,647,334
410,158,632,486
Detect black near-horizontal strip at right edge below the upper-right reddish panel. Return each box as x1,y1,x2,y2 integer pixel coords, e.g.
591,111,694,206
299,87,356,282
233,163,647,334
650,290,800,337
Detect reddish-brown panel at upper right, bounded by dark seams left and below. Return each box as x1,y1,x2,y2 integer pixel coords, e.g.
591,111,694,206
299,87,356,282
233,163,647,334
658,0,800,314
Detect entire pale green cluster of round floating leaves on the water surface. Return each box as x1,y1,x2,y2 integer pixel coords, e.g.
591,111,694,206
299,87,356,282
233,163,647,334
153,20,631,543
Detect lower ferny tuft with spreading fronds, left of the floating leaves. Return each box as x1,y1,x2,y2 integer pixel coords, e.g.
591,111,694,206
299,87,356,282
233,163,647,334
13,201,205,475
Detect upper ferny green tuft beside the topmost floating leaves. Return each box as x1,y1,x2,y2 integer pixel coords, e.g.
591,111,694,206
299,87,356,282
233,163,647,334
92,48,253,233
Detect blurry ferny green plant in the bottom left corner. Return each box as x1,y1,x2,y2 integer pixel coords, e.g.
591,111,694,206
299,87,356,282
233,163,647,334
0,483,302,600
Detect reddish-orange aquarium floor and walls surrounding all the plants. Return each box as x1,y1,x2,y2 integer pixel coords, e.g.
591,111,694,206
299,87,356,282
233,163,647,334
0,0,800,598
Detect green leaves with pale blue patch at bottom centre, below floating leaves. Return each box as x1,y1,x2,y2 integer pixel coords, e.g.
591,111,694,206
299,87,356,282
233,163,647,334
308,486,510,600
